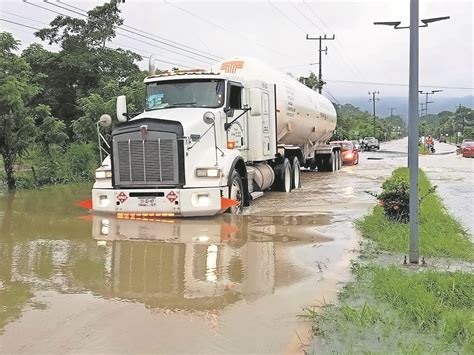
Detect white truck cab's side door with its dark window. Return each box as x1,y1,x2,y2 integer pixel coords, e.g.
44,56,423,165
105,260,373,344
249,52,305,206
227,82,248,150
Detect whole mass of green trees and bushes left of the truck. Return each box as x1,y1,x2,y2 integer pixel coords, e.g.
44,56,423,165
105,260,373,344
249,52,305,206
0,1,146,190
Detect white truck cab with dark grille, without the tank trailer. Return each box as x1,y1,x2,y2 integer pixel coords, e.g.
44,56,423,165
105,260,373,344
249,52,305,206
92,70,276,218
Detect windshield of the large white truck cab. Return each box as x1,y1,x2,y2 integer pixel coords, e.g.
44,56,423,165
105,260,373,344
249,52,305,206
146,79,224,111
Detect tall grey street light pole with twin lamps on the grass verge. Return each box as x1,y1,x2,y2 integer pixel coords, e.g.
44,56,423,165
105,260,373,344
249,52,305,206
374,8,449,264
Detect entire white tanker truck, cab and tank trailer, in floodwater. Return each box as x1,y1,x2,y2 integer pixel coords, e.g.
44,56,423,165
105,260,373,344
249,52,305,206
92,57,342,219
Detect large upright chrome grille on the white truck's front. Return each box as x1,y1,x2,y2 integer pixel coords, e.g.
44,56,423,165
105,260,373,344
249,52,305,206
114,132,178,186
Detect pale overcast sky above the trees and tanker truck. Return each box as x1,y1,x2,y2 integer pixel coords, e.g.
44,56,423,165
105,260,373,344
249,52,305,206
0,0,474,99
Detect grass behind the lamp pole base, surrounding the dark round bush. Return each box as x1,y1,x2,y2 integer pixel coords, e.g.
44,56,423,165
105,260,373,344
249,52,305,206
356,168,474,261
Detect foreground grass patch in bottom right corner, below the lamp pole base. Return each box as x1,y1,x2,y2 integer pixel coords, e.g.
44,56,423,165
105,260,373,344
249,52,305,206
302,264,474,354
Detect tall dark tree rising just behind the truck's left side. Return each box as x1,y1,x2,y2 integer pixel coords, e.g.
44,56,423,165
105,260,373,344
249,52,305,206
28,1,141,128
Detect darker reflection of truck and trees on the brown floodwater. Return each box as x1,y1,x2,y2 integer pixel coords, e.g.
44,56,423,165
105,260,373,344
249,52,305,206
0,186,330,332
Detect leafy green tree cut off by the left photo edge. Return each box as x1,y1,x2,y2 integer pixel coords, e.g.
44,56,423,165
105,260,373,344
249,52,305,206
0,32,39,190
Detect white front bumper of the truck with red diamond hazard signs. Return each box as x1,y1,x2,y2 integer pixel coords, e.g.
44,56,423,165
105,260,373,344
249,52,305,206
92,187,227,218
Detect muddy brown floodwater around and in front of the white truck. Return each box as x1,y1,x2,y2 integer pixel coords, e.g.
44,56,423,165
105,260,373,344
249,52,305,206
0,167,378,353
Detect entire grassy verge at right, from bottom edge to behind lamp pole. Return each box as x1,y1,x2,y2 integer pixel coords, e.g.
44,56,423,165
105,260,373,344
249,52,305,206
301,168,474,354
